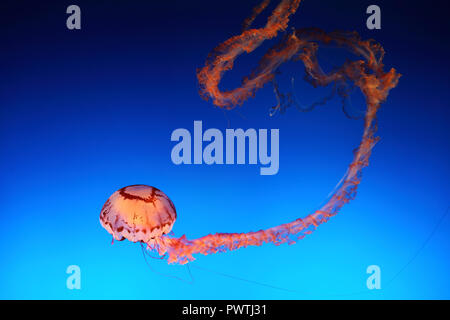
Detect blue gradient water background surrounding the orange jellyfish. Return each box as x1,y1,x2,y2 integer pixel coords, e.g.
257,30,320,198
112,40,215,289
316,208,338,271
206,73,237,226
0,0,450,299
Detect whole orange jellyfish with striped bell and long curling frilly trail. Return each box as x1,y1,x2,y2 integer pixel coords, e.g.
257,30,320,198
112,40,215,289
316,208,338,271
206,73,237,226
100,0,401,264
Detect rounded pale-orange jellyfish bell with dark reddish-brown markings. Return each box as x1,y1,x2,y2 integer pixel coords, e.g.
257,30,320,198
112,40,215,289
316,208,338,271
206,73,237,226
100,185,177,247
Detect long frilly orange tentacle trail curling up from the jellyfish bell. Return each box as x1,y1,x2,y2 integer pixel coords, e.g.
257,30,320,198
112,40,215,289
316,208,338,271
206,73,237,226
158,0,400,264
